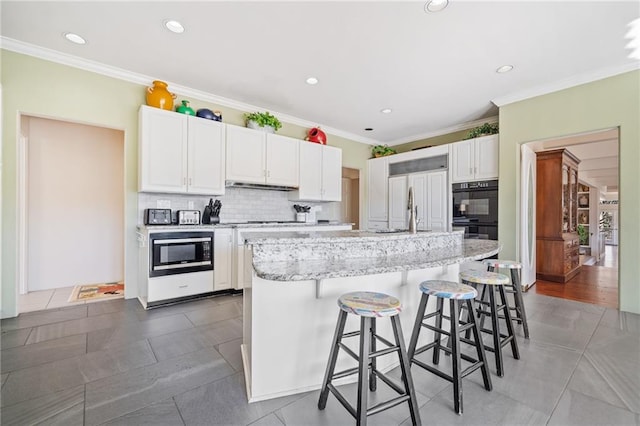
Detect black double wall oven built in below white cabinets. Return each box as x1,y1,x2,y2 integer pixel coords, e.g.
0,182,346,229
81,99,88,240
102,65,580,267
452,180,498,240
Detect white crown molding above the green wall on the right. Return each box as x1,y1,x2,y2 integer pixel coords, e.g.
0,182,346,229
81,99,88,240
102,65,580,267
491,61,640,108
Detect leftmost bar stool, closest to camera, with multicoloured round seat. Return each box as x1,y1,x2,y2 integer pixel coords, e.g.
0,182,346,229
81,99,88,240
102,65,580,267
318,291,421,426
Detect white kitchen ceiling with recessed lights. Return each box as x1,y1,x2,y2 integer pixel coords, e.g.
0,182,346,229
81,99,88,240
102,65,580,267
0,0,640,145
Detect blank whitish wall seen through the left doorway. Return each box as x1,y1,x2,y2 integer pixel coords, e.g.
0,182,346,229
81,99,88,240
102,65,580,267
25,117,124,291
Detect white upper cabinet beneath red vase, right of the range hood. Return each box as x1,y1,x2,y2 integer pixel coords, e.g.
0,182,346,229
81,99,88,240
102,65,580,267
289,142,342,201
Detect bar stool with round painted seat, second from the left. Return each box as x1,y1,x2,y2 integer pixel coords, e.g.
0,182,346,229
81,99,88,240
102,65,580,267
408,280,492,414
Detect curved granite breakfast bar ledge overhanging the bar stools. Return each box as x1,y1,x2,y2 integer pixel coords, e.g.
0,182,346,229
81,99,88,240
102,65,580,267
253,240,501,281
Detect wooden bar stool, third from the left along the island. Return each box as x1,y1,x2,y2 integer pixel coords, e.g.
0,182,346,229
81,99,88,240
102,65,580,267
459,271,520,377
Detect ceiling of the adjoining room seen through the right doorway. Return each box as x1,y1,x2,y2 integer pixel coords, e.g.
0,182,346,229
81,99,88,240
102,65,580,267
528,129,620,194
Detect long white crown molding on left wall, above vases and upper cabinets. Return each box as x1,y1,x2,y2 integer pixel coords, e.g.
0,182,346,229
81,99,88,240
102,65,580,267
0,37,379,145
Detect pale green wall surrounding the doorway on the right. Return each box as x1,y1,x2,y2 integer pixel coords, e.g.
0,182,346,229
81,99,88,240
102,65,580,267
498,71,640,313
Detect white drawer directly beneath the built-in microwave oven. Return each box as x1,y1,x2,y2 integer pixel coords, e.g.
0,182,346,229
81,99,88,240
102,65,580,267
147,271,213,302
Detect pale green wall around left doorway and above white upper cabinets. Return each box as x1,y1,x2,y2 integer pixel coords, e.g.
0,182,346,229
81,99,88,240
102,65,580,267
0,50,370,317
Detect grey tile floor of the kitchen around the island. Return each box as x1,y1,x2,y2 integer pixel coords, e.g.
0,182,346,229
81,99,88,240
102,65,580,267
0,292,640,426
